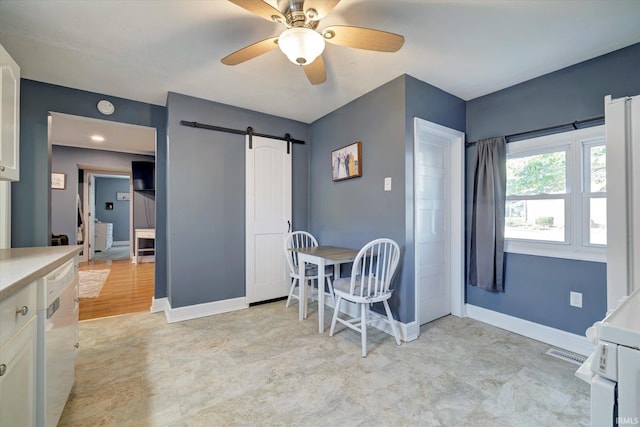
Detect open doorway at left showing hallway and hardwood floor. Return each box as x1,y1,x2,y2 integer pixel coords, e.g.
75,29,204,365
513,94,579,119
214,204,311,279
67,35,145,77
49,112,156,320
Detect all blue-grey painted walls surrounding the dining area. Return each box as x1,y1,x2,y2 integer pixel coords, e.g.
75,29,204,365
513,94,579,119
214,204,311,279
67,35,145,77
18,40,640,334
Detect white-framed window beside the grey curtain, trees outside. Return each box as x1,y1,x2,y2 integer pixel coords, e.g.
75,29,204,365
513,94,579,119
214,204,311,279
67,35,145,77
505,126,607,261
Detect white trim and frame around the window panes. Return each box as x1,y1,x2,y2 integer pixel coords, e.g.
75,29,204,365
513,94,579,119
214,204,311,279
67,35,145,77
505,125,607,262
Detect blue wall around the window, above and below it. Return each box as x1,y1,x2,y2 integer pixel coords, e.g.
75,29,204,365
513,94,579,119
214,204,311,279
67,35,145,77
466,44,640,335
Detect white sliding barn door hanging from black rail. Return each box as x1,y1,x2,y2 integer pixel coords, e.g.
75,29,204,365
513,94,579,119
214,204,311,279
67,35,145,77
246,136,291,304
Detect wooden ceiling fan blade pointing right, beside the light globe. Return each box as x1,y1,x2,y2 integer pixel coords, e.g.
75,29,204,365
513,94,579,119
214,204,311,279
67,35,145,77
322,25,404,52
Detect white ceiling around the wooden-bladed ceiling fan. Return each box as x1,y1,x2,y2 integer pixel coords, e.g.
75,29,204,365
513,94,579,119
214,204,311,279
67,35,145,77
0,0,640,127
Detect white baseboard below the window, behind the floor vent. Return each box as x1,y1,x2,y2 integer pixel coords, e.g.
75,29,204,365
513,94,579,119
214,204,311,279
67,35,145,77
465,304,594,356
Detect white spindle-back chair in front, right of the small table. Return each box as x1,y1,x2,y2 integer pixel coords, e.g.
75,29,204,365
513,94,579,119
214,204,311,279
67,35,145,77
329,239,400,357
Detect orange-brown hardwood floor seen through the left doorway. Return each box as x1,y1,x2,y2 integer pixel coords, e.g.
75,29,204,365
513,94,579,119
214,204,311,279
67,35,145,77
80,259,155,320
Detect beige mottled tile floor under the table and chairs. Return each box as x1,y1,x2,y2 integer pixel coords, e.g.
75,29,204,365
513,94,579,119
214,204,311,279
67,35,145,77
59,301,589,427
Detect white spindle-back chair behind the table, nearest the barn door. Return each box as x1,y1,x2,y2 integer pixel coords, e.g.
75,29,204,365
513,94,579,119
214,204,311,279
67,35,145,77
284,231,335,317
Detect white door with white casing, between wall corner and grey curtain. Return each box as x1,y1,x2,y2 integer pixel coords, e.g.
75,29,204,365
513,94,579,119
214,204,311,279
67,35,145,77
414,119,464,325
